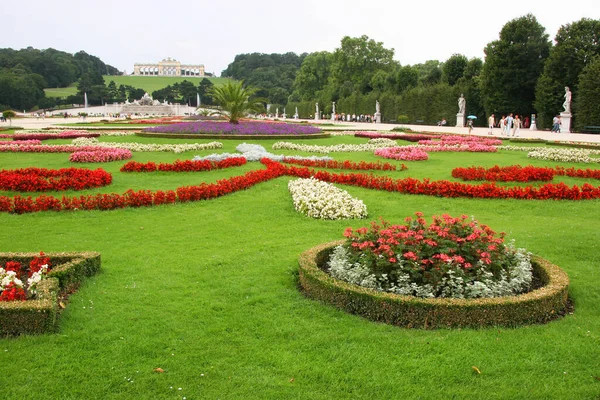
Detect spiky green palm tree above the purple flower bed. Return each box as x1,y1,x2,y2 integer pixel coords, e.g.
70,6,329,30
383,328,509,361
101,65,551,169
210,81,266,124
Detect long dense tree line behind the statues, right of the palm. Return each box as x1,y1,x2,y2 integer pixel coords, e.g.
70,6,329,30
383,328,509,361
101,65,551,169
223,14,600,129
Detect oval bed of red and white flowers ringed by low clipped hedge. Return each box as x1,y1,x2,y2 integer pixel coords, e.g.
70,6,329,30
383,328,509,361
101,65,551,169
299,214,569,328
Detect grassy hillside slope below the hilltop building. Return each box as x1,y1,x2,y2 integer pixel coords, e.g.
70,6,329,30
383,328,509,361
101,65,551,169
44,75,229,97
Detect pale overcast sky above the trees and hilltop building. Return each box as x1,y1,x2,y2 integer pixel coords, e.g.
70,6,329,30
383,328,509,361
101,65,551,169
0,0,600,76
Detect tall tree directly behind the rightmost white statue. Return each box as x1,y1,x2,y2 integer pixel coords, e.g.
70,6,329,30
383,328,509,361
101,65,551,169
535,18,600,127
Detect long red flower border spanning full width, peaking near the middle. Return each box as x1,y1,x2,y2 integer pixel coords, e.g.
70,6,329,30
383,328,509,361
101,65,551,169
0,159,600,214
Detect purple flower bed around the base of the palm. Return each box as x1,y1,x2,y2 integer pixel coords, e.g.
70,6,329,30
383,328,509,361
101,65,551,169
144,121,321,135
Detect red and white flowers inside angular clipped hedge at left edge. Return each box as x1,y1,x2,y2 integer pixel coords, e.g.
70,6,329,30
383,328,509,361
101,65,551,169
0,252,52,301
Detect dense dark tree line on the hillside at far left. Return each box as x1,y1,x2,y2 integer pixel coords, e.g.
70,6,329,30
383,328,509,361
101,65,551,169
0,47,120,110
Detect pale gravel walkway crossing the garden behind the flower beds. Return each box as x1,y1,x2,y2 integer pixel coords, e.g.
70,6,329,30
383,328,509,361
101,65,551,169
0,117,600,143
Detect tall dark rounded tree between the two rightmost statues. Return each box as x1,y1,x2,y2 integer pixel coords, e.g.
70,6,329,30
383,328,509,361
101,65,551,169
481,14,551,114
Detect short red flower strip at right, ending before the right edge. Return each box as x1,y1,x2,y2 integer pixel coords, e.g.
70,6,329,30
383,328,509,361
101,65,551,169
452,165,555,182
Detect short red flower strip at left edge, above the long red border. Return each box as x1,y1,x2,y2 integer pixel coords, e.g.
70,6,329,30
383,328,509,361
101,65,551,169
0,168,112,192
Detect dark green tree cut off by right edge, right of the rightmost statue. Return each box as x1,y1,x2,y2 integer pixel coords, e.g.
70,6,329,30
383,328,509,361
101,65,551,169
573,56,600,131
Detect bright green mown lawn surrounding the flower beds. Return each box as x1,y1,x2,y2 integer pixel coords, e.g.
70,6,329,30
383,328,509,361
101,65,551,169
0,137,600,399
